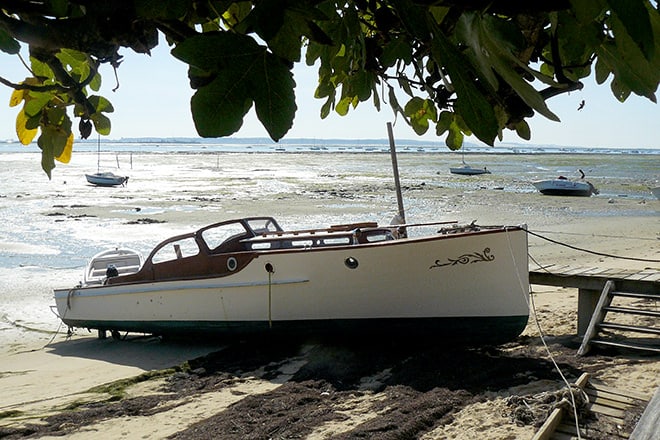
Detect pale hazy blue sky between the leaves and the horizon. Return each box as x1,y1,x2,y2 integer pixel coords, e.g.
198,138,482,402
0,39,660,149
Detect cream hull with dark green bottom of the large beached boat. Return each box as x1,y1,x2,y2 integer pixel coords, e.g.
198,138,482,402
55,228,529,343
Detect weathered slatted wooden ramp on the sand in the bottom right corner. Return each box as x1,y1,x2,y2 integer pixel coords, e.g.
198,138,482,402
532,373,660,440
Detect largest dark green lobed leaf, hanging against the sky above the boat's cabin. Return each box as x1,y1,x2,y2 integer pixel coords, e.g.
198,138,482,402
177,32,296,140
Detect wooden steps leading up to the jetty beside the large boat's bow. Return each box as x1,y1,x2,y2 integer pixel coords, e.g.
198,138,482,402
578,280,660,356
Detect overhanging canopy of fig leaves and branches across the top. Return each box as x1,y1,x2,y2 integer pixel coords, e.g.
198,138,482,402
0,0,660,175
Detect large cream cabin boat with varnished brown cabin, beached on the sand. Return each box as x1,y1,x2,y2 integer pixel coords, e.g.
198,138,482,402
54,217,529,344
